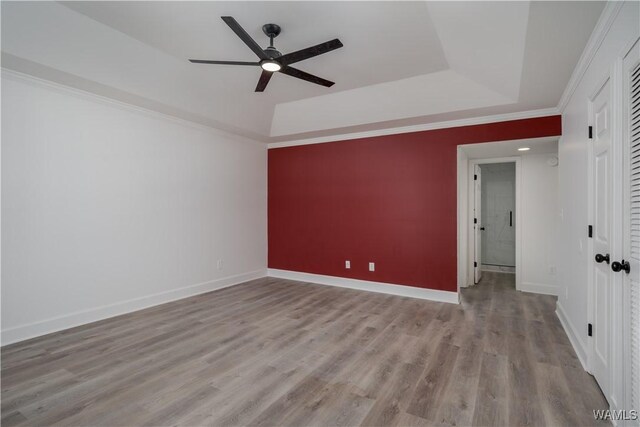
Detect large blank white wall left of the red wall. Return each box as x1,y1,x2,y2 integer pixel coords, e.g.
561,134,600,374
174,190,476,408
2,72,267,344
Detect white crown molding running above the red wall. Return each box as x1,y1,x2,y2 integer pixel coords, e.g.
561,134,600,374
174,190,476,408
267,107,560,149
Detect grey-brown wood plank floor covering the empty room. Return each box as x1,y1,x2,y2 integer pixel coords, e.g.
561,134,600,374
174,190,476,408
2,273,607,427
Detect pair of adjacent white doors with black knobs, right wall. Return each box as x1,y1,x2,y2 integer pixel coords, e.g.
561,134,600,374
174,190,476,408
586,39,640,414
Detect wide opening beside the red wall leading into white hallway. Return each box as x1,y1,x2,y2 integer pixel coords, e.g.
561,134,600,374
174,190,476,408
458,137,558,295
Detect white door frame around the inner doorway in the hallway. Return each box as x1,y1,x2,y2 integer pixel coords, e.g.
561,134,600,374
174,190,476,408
458,157,522,290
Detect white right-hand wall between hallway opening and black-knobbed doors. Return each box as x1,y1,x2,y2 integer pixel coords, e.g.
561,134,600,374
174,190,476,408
558,1,640,372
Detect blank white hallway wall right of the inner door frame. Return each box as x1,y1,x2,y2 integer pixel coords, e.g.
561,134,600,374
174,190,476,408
520,154,558,295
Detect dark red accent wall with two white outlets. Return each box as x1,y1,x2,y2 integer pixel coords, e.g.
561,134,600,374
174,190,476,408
268,116,561,291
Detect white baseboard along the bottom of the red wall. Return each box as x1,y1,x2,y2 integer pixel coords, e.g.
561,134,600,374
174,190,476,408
267,268,459,304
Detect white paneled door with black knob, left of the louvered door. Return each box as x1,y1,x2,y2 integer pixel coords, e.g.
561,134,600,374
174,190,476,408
590,80,612,398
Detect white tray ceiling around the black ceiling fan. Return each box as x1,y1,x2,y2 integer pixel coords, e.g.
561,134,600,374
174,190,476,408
0,1,604,142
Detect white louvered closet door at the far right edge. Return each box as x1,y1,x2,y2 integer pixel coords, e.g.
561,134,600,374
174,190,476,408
619,42,640,423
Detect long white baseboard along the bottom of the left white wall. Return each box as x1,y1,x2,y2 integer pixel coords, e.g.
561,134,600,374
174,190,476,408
1,269,267,346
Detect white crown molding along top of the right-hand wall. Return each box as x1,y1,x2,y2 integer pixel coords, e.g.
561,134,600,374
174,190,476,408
558,1,625,113
